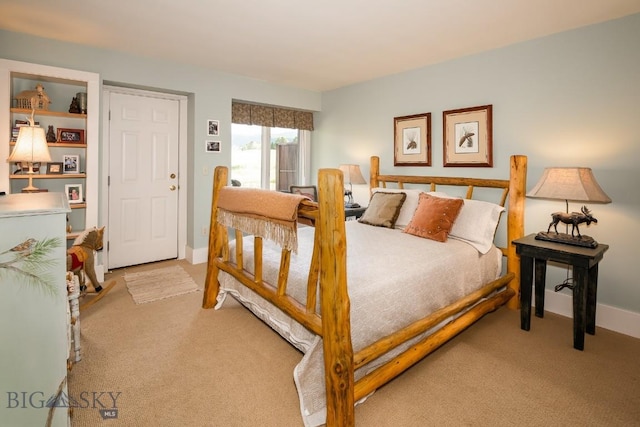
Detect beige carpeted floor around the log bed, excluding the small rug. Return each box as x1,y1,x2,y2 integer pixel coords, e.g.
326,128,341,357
69,261,640,427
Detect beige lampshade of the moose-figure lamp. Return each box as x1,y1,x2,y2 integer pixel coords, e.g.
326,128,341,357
527,168,611,203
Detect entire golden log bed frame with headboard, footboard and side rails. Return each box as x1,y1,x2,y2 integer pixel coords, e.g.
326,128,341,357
202,155,527,426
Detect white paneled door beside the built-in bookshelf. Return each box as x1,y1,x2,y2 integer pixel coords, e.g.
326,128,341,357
108,93,179,268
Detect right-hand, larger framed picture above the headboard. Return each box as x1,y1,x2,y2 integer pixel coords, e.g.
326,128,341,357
442,105,493,167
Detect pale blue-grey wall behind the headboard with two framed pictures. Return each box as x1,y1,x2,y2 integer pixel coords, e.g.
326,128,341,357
312,15,640,313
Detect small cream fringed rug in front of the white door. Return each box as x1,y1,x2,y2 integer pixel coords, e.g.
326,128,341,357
124,265,198,304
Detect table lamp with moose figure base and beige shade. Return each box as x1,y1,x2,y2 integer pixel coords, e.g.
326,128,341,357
527,167,611,248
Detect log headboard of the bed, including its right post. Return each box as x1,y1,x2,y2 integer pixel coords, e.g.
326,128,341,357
369,155,527,309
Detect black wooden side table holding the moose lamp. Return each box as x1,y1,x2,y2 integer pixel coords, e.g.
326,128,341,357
512,234,609,350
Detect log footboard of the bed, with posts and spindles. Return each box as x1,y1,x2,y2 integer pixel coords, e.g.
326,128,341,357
202,167,354,425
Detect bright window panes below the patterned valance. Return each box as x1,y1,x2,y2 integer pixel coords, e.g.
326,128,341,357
231,123,310,190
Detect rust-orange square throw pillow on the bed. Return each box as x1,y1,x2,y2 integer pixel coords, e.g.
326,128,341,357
403,193,464,242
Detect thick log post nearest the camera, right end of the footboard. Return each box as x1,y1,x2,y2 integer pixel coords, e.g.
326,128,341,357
316,169,355,427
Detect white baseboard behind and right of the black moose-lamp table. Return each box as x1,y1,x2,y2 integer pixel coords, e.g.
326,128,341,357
544,289,640,338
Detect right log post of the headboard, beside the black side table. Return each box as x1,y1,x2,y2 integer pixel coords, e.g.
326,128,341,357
507,155,527,310
